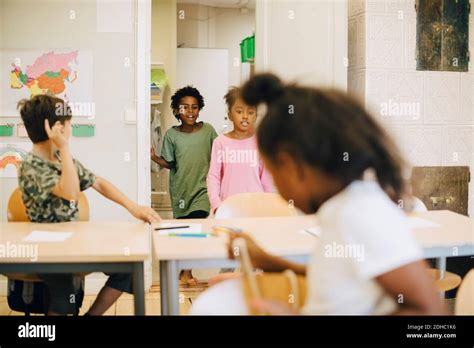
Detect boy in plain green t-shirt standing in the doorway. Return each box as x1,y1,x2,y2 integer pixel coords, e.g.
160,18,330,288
151,86,217,284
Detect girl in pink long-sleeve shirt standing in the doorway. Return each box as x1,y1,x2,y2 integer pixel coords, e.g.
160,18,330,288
207,87,274,212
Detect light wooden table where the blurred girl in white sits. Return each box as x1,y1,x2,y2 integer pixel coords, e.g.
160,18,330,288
152,211,474,315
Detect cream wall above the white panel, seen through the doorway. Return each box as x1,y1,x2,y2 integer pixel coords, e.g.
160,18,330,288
177,4,255,87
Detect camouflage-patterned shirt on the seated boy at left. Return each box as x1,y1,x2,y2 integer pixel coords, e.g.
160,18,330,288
18,152,95,222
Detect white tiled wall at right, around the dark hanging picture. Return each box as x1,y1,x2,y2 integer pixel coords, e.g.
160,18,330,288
349,0,474,216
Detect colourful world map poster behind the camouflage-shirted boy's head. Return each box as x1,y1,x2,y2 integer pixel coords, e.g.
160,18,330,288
0,50,95,117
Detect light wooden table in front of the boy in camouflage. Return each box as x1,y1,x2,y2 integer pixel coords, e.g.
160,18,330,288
0,221,151,315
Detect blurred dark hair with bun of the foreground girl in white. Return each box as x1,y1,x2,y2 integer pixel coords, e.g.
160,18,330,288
242,74,405,203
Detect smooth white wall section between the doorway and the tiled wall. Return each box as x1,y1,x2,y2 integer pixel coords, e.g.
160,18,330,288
255,0,347,90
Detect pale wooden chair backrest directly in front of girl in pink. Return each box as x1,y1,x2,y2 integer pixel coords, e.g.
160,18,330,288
215,192,298,219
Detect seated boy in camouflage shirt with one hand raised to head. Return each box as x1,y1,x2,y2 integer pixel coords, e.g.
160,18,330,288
18,95,160,315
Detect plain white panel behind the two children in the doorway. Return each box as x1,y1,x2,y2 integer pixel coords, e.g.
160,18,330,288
176,48,231,134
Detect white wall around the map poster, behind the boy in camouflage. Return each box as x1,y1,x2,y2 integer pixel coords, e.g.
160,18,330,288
0,0,137,221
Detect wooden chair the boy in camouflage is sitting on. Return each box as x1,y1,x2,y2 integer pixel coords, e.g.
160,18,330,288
3,187,89,315
